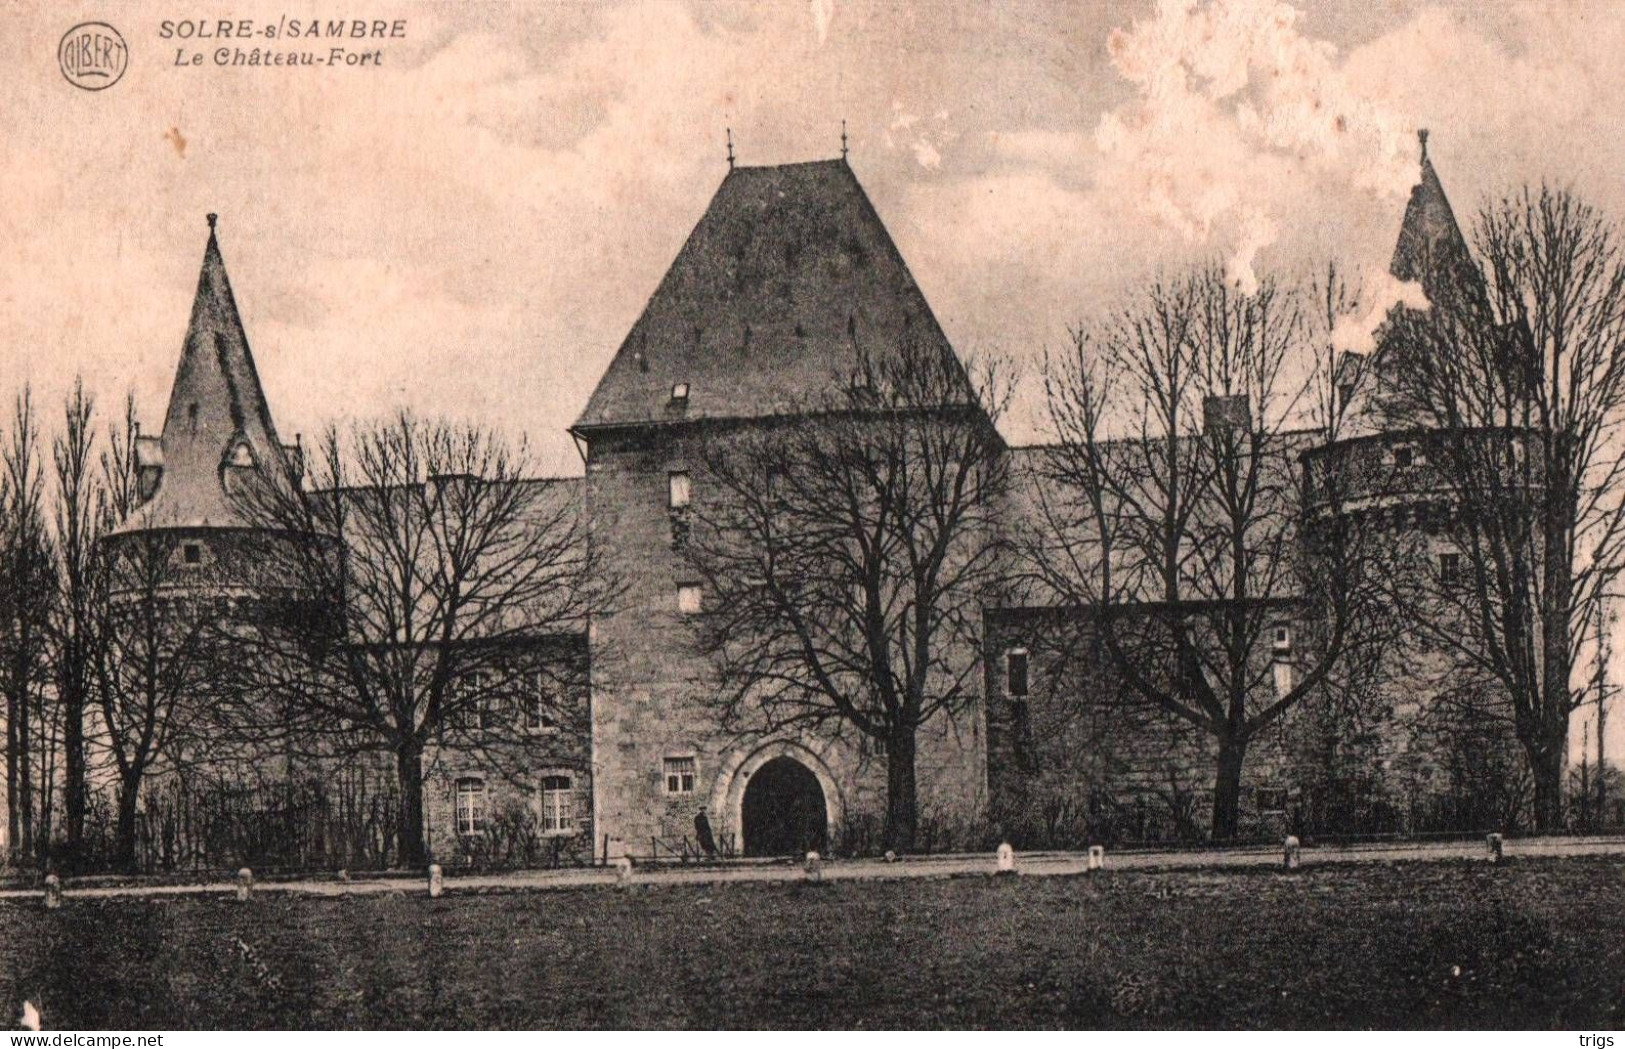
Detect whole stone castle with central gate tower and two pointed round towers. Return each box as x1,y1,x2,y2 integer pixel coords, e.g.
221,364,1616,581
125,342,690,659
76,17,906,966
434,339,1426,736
112,139,1534,859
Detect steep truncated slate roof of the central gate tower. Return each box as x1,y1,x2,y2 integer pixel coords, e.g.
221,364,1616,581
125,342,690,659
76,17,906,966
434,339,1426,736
575,159,954,429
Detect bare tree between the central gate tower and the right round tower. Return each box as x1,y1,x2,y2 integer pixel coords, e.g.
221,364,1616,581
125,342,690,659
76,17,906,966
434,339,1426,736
1027,270,1368,840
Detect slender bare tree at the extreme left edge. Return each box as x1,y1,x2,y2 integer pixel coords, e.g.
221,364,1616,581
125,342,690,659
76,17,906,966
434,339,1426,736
0,390,55,857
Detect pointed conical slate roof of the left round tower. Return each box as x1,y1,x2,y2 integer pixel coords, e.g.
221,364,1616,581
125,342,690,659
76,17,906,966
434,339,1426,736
125,214,286,528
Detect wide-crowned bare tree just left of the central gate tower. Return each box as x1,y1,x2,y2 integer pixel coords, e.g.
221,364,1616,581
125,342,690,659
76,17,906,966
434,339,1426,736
219,414,613,866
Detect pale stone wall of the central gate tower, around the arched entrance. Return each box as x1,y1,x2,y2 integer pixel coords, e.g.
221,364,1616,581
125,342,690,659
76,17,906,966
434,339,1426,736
587,425,985,856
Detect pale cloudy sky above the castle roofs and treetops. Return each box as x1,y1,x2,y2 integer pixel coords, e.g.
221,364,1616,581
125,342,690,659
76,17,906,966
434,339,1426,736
0,0,1625,753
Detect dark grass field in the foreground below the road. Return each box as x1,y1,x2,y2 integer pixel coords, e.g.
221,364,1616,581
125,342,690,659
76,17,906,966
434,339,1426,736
0,857,1625,1030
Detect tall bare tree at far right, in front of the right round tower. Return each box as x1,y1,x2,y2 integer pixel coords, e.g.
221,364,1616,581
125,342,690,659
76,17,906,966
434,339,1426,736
1391,187,1625,830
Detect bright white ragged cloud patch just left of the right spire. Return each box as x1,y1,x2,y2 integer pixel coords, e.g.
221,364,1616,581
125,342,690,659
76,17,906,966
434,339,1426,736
1095,0,1415,295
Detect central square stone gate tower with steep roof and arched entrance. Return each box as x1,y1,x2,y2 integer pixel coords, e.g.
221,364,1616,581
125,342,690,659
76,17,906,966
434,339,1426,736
572,159,985,856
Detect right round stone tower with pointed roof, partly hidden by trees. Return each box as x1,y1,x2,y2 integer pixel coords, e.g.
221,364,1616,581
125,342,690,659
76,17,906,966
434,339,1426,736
1305,132,1521,828
